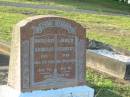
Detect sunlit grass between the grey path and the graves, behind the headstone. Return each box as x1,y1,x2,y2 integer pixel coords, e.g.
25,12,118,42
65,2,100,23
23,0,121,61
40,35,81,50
0,6,130,50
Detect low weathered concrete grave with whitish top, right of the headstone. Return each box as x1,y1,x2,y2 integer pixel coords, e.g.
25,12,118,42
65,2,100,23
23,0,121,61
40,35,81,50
86,50,130,79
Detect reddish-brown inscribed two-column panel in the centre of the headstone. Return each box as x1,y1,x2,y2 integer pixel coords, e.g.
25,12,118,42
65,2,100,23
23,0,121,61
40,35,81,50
34,35,75,82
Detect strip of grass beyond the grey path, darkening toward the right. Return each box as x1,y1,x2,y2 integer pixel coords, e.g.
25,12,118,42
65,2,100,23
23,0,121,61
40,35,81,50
0,0,130,15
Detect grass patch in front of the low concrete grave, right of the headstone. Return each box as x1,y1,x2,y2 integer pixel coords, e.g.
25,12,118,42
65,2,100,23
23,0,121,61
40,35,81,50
86,69,130,97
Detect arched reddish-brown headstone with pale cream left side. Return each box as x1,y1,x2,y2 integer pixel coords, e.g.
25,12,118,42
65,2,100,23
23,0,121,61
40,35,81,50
8,16,86,92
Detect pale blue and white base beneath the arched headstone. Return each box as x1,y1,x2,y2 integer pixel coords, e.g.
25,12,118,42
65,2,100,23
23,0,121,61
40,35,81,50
0,85,94,97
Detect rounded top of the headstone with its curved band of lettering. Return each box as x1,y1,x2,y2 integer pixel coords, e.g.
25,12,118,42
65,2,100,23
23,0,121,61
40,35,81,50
16,15,86,38
